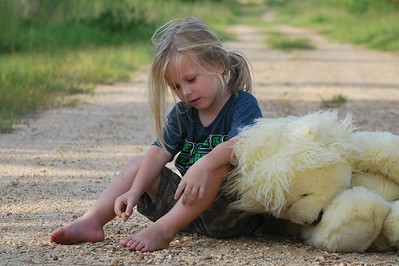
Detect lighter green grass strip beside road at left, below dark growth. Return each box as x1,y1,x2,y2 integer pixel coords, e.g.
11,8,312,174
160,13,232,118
0,44,150,131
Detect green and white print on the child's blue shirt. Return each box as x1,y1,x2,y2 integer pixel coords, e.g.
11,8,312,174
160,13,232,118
175,135,228,173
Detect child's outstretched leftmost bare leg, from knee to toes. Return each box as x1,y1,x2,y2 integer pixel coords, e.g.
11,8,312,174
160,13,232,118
50,155,143,244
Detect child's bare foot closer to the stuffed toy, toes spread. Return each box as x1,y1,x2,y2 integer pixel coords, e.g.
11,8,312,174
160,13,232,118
120,223,176,252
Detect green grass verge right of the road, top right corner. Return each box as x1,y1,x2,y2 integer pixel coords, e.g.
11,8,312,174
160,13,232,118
268,0,399,53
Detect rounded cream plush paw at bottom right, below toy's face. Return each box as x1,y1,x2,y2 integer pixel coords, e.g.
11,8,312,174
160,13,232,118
305,187,391,252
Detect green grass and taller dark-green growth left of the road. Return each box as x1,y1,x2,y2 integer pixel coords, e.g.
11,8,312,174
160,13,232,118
0,0,247,132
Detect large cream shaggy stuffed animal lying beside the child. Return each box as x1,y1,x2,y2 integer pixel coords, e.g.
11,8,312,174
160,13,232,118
224,111,399,252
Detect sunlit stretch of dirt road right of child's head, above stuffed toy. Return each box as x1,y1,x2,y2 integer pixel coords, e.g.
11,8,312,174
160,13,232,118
225,23,399,133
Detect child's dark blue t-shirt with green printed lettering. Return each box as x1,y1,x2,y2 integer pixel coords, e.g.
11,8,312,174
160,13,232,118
154,91,262,176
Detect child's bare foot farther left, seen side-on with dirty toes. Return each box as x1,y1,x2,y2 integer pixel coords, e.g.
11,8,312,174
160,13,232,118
50,217,104,245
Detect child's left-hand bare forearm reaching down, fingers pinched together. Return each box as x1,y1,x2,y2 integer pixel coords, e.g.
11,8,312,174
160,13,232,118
114,145,172,217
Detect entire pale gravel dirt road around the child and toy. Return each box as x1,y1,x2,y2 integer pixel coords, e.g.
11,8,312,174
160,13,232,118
0,21,399,265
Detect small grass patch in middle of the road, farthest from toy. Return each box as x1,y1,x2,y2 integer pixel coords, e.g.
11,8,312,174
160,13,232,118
266,33,315,51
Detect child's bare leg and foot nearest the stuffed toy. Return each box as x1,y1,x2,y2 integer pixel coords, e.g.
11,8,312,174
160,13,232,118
120,168,228,252
